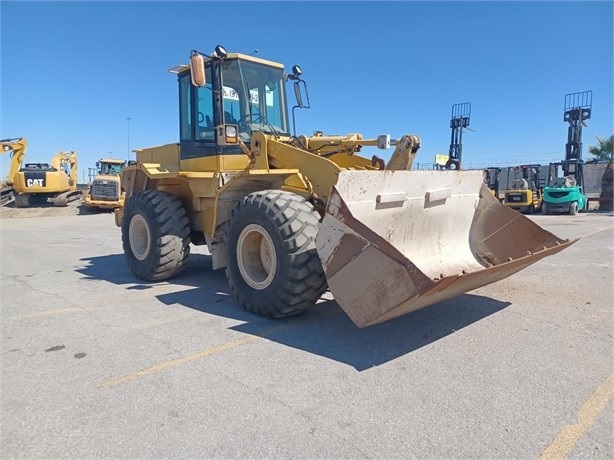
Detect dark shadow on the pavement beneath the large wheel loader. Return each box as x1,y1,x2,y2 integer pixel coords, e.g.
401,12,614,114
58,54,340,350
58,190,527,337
78,254,510,371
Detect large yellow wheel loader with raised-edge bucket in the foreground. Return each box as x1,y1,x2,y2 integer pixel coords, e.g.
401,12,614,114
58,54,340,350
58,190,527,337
115,46,574,327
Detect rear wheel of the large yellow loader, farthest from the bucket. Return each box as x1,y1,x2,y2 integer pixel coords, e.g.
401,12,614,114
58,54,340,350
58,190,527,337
122,190,190,281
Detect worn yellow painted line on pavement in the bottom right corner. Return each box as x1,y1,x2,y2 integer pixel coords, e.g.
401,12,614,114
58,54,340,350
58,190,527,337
540,373,614,460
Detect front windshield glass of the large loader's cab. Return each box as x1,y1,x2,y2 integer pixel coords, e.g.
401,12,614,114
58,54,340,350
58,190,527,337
222,60,289,142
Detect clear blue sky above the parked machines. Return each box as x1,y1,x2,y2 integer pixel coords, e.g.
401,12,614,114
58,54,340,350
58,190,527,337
0,0,614,180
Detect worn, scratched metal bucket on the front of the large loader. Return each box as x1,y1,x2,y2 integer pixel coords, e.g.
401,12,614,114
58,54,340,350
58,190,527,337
316,170,577,327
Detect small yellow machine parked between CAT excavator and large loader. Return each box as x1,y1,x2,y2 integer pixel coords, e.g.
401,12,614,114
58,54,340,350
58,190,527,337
83,158,126,209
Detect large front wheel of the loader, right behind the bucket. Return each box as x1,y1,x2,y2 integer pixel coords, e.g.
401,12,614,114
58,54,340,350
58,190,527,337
225,190,327,318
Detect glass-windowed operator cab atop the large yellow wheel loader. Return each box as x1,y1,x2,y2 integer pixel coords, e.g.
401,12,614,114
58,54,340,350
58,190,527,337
170,47,290,159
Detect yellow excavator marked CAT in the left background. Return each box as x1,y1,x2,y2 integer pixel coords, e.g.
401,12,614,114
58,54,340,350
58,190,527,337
1,137,82,208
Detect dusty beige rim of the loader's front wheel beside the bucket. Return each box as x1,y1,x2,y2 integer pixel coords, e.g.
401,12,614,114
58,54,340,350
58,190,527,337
237,224,277,290
